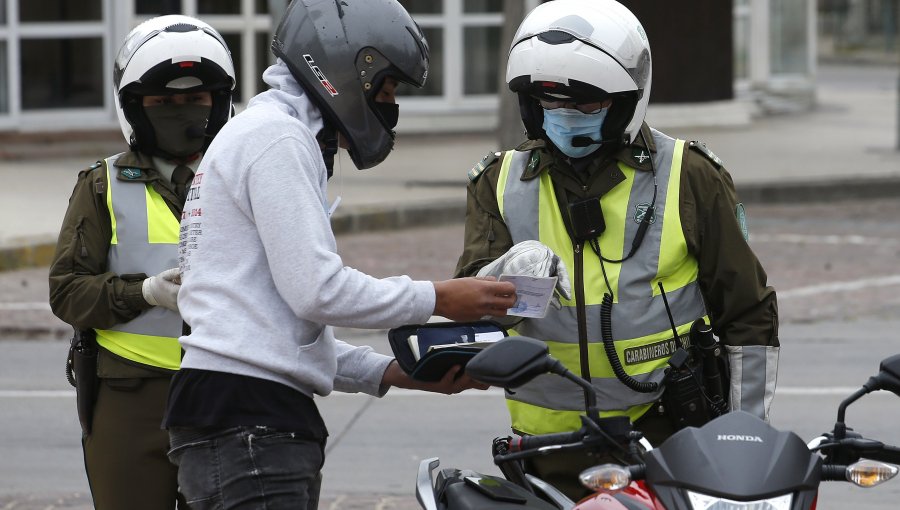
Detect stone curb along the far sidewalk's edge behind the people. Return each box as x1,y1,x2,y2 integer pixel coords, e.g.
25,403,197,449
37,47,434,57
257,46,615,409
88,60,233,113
0,179,900,271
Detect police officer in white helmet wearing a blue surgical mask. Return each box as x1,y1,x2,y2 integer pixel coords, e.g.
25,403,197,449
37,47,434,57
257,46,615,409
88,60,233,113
457,0,780,499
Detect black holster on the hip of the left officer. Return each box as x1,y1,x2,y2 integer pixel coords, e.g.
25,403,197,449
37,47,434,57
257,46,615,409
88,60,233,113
66,330,99,435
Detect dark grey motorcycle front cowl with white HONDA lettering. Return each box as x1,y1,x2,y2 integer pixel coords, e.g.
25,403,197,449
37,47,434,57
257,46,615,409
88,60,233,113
645,411,821,501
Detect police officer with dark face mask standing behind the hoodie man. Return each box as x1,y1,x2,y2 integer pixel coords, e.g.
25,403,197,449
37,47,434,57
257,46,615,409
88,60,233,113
50,15,235,510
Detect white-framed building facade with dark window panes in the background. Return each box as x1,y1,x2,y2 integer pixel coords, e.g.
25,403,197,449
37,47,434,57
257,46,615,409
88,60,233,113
0,0,816,132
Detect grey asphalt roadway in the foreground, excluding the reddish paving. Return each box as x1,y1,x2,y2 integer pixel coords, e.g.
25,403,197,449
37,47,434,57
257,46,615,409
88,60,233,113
0,319,900,510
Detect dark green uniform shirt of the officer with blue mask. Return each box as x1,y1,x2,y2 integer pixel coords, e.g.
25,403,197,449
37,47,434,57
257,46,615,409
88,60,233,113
456,124,779,346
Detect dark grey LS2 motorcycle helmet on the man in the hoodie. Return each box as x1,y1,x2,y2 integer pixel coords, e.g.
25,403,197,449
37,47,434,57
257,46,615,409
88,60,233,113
272,0,428,170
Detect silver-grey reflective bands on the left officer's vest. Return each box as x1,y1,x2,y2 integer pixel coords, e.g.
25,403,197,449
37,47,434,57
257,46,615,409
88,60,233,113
106,154,181,338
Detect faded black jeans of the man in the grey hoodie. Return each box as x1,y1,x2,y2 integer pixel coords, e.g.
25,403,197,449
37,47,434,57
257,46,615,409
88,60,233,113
169,427,325,510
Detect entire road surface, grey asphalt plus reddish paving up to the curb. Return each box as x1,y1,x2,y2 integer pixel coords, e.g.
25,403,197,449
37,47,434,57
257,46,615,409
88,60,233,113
0,196,900,510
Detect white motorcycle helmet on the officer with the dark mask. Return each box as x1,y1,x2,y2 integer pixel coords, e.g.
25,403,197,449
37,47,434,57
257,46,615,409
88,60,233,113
113,15,235,155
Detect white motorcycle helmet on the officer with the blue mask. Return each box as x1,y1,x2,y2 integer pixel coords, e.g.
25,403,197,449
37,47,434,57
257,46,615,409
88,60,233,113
506,0,651,145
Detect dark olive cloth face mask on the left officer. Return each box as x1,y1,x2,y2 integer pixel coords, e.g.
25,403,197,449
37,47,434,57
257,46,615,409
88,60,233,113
144,104,212,158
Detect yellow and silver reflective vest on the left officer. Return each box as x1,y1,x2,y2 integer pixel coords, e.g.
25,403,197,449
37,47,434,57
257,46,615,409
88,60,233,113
95,155,182,370
